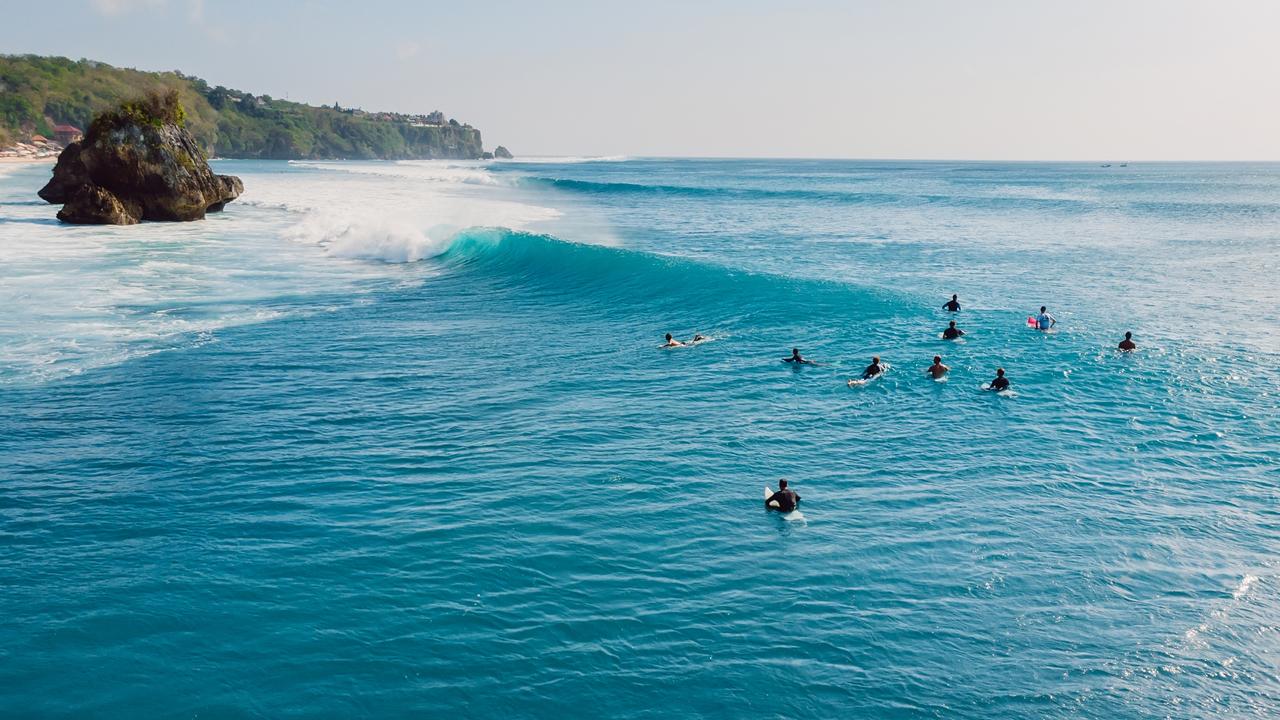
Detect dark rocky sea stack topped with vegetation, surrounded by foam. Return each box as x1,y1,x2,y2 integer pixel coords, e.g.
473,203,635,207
40,91,244,225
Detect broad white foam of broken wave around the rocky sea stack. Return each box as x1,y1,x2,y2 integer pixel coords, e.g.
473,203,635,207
0,155,559,383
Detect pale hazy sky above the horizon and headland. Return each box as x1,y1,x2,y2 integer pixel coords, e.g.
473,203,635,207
0,0,1280,160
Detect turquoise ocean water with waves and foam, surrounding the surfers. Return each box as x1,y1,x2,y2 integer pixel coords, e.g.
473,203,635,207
0,159,1280,719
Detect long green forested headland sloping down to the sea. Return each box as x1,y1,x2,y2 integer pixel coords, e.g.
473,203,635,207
0,55,484,160
